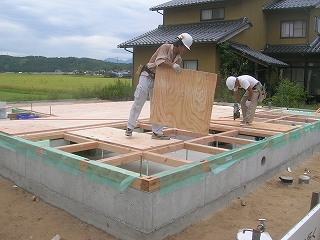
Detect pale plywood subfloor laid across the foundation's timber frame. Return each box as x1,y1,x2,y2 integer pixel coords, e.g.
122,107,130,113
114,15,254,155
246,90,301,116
0,101,310,155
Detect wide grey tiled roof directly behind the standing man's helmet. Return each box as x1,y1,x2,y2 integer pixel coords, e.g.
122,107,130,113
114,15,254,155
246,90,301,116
118,18,252,48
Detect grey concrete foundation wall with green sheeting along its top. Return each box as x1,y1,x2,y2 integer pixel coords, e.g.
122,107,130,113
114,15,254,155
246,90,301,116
0,122,320,239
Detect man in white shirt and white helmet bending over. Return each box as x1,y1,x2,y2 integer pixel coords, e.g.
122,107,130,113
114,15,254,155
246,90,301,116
226,75,262,126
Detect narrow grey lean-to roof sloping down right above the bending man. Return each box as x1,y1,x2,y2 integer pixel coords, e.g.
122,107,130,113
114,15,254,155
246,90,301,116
228,41,289,67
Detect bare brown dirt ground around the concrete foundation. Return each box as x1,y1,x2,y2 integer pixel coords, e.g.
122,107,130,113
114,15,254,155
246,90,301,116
0,100,320,240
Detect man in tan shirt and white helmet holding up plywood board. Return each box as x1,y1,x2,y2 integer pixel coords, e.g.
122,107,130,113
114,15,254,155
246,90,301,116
125,33,193,140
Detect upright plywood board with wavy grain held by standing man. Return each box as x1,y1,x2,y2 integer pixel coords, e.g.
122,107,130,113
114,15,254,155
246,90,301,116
150,67,217,134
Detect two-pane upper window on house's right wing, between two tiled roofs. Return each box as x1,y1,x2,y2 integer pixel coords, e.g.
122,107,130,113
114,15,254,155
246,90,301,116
281,20,307,38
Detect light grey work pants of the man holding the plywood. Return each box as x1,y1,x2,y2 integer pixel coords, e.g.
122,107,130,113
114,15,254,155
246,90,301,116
127,75,163,134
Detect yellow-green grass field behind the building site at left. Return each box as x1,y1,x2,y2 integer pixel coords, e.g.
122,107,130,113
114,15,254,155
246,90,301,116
0,73,132,102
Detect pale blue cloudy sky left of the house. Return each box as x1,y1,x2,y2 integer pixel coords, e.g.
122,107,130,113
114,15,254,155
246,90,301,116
0,0,169,60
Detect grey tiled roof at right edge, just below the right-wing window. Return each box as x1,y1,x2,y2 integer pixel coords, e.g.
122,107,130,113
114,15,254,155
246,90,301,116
262,35,320,55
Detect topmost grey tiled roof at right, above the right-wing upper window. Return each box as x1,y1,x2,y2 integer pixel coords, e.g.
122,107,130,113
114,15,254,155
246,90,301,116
262,0,320,10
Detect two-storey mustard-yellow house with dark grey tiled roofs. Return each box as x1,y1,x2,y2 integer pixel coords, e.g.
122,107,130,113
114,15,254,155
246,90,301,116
118,0,320,99
